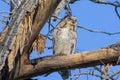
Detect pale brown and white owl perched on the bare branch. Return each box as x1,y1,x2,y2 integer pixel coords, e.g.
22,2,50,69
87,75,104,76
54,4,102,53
53,16,77,80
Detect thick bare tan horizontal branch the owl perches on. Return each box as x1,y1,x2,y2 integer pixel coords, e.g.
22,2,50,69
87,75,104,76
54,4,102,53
15,47,120,80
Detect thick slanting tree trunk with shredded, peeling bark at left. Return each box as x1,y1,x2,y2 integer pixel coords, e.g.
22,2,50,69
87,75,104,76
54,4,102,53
0,0,61,80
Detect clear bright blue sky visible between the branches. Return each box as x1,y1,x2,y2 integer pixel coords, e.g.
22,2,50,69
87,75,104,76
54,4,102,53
0,0,120,80
